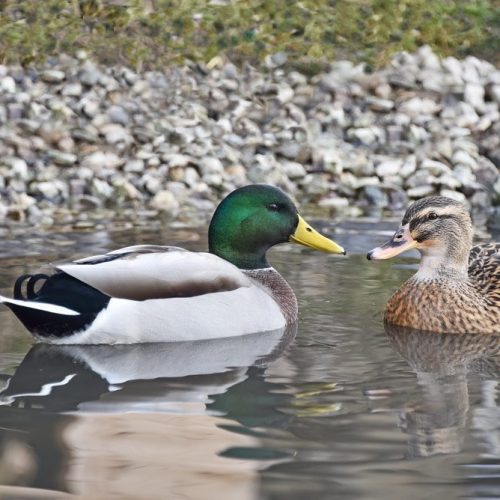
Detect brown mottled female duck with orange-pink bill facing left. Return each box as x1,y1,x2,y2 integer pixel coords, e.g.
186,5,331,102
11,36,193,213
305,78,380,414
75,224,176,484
367,196,500,333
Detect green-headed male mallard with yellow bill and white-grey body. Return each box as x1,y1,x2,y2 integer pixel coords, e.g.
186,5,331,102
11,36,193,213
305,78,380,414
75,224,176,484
0,185,345,344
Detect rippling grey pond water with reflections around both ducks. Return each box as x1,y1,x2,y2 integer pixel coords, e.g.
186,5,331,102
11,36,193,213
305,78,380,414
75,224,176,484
0,222,500,500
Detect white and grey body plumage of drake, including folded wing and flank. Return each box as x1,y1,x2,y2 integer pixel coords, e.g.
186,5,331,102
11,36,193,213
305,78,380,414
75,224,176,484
8,246,286,344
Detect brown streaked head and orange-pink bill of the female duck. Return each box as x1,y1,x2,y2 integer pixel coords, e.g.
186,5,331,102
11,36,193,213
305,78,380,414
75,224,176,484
367,196,473,276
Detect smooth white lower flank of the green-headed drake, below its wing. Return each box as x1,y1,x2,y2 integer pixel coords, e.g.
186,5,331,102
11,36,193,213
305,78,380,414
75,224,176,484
51,285,286,344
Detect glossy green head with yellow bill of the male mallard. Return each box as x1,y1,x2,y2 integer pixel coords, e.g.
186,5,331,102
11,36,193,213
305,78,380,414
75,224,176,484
208,184,345,269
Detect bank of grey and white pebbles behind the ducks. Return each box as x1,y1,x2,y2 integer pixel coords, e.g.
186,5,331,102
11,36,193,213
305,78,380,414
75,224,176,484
0,47,500,225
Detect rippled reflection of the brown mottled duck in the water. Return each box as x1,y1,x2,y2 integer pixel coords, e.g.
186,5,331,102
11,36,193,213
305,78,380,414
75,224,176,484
385,324,500,457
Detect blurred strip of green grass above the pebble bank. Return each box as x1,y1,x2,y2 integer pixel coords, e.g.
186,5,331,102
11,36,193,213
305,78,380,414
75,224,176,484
0,0,500,69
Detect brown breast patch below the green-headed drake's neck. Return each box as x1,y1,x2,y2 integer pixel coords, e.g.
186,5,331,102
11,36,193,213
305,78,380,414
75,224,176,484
243,267,299,325
